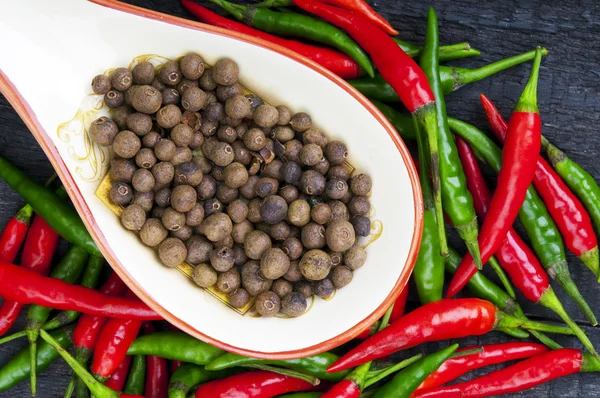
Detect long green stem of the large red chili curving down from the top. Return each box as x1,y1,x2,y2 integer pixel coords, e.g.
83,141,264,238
416,103,450,257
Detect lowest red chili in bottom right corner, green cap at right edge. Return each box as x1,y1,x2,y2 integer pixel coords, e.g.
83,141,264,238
415,348,600,398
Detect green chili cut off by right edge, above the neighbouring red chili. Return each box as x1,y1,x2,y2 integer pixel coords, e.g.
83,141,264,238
542,137,600,281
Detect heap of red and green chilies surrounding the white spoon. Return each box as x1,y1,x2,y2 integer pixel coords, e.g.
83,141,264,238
0,0,600,398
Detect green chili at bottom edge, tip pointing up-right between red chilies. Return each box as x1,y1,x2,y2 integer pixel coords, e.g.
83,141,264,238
374,344,458,398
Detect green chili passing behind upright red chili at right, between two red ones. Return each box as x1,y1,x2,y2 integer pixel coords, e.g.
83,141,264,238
448,118,596,323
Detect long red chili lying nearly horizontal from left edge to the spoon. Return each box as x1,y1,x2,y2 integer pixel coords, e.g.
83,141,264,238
0,263,162,321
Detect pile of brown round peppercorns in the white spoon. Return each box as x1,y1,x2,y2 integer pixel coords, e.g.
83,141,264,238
89,54,372,316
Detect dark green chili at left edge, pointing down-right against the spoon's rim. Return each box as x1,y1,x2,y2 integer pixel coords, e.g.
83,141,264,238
0,156,102,256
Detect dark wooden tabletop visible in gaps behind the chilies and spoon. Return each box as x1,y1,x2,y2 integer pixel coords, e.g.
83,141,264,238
0,0,600,398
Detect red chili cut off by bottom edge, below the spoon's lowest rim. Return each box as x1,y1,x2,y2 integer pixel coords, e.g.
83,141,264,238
195,370,314,398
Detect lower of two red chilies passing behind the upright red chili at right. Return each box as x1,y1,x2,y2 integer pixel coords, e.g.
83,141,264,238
456,137,595,352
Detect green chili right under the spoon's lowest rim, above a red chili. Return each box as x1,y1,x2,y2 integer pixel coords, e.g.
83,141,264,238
206,352,349,381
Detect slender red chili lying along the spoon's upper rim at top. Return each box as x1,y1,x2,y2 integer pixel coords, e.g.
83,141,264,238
181,0,361,79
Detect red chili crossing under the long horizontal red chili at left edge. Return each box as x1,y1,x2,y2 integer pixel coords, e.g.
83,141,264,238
0,216,60,336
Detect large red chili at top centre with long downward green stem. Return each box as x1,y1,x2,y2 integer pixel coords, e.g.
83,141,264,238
294,0,448,254
